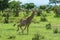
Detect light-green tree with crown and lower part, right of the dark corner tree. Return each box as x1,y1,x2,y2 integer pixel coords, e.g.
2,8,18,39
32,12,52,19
9,1,21,17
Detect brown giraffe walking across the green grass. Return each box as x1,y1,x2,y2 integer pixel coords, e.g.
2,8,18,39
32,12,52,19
17,11,36,34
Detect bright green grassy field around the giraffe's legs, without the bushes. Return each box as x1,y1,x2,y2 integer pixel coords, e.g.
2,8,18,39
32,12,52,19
0,12,60,40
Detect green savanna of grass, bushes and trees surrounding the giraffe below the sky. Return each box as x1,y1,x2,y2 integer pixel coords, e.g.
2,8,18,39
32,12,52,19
0,0,60,40
